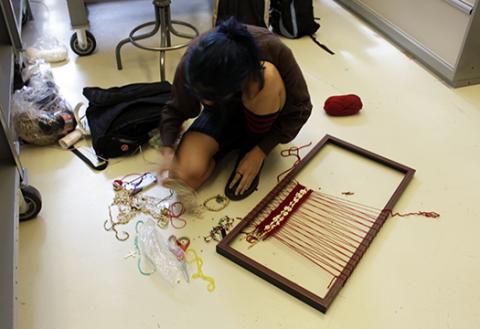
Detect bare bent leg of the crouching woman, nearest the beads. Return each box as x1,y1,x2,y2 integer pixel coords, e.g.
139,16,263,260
175,131,219,189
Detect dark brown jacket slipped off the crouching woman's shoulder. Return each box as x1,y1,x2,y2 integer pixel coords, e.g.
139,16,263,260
160,26,312,154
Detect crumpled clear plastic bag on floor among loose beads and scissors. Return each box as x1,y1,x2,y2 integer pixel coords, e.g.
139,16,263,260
135,219,189,285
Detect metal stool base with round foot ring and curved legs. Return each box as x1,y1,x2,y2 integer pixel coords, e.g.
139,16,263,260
115,0,198,81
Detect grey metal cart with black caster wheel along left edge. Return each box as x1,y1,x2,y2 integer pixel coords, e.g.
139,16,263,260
0,0,42,329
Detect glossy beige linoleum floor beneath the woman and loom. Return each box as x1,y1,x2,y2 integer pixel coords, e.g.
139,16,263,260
17,0,480,329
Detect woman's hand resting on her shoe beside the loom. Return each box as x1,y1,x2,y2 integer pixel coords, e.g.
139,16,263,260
229,146,266,195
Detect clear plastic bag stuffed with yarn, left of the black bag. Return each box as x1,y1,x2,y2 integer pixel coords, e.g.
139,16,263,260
12,61,76,145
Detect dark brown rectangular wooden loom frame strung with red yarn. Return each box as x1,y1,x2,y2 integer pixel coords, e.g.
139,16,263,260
216,135,415,313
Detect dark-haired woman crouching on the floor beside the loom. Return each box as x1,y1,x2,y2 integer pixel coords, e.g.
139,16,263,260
160,18,312,200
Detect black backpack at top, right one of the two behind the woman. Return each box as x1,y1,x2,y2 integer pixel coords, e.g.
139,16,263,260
270,0,320,39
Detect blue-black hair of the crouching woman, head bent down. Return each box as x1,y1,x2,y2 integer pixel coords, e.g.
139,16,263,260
185,17,263,102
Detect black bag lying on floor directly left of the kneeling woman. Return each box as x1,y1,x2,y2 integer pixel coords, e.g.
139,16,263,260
83,82,171,159
